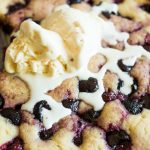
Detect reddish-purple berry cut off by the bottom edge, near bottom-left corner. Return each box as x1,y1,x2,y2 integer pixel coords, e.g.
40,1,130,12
7,139,23,150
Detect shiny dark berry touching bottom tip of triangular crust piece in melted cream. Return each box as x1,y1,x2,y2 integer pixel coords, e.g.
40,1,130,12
62,99,80,112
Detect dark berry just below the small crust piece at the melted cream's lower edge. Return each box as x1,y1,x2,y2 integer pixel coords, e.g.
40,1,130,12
79,109,100,122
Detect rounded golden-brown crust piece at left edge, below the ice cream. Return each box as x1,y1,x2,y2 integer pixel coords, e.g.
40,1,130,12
0,73,30,107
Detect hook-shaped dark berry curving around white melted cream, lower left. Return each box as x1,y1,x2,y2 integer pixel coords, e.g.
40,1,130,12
33,100,51,122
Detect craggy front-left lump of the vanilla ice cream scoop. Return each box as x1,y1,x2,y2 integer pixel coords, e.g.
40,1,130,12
5,20,67,75
